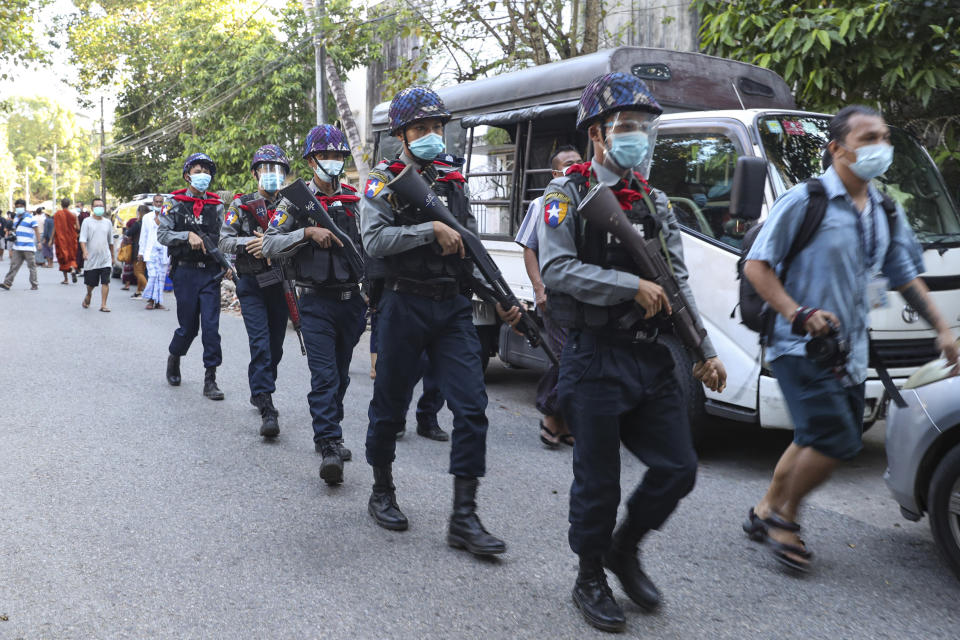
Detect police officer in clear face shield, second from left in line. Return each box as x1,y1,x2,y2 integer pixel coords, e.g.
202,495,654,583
220,144,290,438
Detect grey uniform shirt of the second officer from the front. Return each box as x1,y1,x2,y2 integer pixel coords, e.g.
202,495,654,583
360,153,483,280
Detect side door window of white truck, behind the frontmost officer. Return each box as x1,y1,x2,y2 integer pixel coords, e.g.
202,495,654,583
650,131,749,250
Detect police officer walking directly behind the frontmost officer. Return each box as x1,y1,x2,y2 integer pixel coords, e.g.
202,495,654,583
360,87,519,556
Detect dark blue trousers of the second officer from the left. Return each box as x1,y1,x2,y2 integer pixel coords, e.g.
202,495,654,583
237,275,289,396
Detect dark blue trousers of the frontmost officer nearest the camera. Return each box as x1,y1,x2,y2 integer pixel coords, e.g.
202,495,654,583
558,331,697,556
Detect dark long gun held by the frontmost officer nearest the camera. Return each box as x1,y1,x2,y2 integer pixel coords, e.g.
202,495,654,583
577,184,707,361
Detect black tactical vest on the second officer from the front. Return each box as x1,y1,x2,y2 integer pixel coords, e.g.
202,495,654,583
384,165,470,280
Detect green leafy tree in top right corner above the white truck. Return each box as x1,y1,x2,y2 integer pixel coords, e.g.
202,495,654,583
692,0,960,193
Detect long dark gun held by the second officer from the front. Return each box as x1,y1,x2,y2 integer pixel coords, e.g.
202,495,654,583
387,165,560,364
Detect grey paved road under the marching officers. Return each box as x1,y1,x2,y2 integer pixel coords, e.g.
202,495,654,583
0,268,960,640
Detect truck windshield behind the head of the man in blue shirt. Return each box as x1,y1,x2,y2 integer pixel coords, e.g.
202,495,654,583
757,113,960,245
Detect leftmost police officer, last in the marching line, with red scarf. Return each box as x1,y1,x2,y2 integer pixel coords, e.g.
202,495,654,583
157,153,231,400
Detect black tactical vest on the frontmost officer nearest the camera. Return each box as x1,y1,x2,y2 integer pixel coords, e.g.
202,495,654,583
547,175,661,331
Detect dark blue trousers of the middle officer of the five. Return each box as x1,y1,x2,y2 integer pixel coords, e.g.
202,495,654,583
300,293,367,442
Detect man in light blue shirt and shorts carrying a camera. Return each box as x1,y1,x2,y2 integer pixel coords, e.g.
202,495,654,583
743,105,957,570
